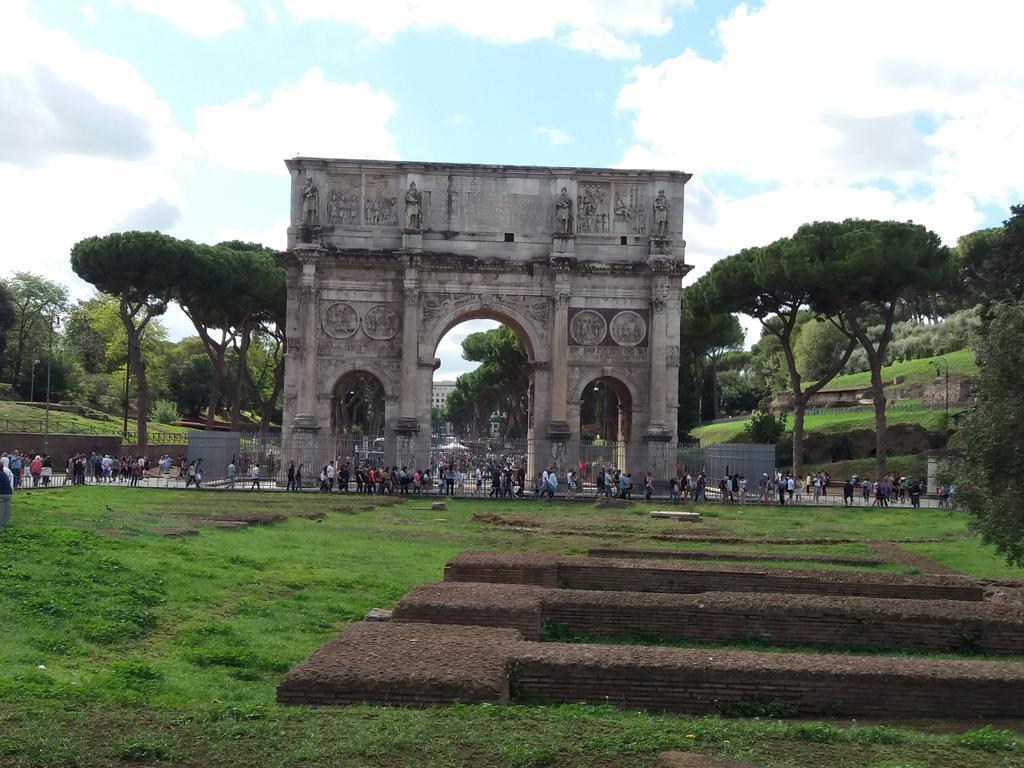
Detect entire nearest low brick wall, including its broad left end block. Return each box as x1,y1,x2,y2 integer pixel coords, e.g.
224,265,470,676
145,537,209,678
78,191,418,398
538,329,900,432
278,624,1024,718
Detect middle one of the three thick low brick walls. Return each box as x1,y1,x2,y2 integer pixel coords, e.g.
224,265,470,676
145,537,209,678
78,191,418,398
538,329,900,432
393,582,1024,655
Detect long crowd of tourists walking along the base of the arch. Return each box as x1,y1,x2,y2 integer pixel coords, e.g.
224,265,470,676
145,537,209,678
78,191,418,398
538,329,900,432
0,451,955,508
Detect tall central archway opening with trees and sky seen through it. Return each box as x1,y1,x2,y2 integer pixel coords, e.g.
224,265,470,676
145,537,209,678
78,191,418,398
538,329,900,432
430,315,535,496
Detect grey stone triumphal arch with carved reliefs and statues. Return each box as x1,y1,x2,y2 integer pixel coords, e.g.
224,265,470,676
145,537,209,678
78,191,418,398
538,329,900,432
284,158,690,478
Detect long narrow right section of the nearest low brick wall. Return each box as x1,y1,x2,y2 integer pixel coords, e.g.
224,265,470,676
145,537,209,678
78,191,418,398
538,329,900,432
514,643,1024,718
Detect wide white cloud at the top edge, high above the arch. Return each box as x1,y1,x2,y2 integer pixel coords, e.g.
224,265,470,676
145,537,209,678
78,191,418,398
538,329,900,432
284,0,693,58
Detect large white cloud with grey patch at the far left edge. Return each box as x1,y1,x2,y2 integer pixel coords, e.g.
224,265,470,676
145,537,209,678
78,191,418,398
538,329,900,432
0,2,193,307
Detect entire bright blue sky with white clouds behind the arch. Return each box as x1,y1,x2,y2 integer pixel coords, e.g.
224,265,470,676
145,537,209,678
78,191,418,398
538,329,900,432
0,0,1024,378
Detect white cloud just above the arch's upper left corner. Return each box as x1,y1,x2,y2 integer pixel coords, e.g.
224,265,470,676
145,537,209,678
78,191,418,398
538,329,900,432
196,69,397,173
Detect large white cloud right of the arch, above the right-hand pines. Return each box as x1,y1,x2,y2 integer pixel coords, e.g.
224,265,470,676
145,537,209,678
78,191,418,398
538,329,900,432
617,0,1024,288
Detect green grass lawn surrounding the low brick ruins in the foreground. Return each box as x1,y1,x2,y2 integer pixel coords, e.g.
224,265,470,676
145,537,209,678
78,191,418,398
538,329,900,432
0,487,1024,768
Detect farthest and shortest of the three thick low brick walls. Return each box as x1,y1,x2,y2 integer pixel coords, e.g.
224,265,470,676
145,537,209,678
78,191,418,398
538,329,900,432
444,552,984,601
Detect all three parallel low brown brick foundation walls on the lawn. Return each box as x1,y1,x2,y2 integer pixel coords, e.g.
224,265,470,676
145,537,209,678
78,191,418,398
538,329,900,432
278,553,1024,719
